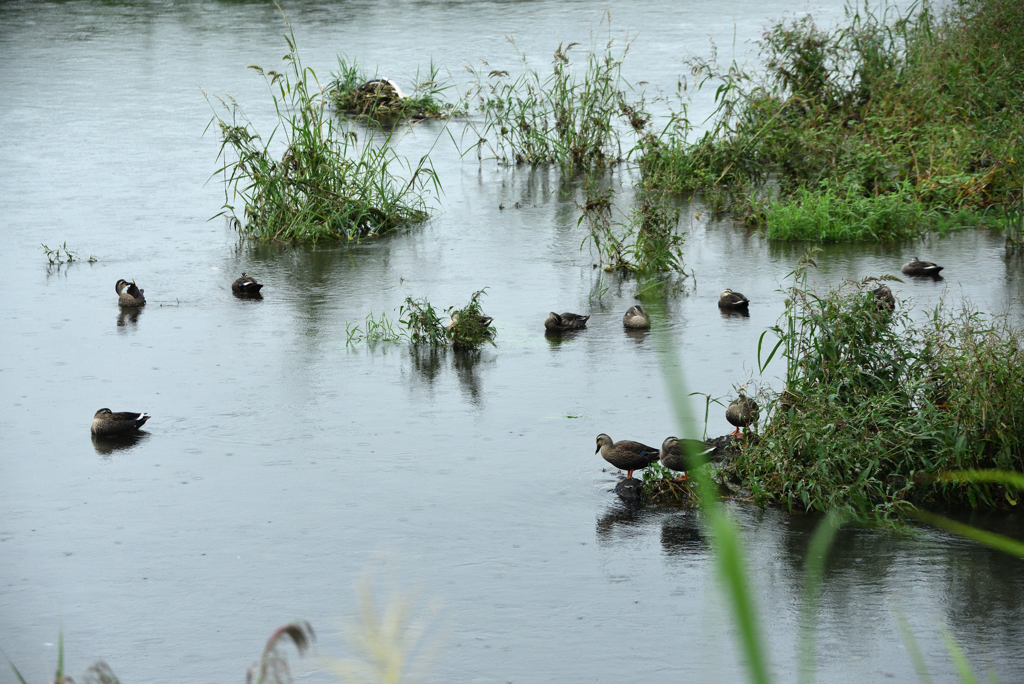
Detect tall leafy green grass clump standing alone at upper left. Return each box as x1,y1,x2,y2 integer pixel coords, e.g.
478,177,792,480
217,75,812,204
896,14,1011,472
205,26,438,243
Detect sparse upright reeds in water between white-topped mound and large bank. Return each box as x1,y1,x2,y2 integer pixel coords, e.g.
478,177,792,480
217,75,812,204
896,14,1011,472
464,20,649,177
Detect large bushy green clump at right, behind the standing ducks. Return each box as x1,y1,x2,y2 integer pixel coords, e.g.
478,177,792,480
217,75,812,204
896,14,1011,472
731,274,1024,517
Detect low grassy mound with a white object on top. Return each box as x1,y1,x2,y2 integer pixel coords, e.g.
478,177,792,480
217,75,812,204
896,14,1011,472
328,57,456,124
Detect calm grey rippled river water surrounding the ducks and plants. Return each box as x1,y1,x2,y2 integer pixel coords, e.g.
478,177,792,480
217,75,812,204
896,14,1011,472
0,2,1024,682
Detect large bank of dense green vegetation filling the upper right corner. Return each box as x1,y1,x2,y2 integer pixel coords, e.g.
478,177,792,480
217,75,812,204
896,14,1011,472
638,0,1024,242
